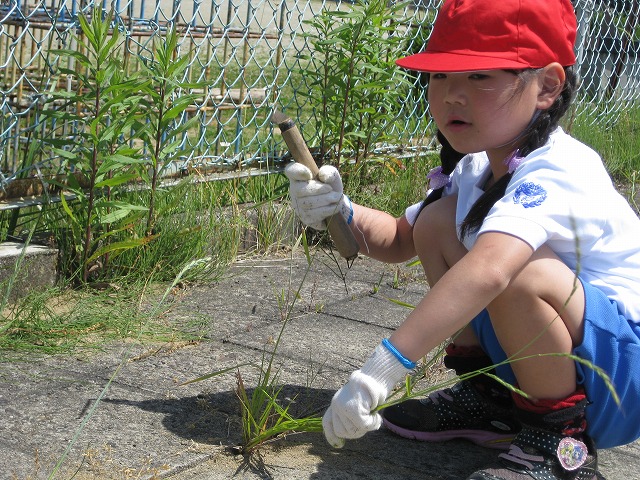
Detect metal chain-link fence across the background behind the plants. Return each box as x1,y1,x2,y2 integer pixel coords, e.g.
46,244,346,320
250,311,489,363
0,0,640,194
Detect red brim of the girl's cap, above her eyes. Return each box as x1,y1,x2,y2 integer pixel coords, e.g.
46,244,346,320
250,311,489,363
396,52,530,72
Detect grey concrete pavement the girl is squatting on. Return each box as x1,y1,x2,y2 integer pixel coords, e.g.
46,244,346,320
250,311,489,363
0,252,640,480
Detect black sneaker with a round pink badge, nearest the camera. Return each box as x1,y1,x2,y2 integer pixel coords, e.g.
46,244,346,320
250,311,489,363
467,427,600,480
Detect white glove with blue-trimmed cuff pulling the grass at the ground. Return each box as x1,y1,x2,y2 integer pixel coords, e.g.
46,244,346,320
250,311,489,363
322,344,411,448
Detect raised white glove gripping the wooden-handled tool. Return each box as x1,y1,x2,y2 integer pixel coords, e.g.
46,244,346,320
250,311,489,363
284,162,353,230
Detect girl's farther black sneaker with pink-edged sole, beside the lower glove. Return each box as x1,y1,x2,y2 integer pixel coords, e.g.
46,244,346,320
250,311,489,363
382,380,520,450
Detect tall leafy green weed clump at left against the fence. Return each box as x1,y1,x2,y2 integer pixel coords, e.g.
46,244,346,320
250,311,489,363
42,8,209,282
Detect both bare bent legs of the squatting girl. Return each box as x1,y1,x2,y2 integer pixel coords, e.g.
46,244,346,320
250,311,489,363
413,195,584,398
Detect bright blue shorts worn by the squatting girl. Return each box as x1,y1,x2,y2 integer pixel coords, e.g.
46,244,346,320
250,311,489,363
471,282,640,448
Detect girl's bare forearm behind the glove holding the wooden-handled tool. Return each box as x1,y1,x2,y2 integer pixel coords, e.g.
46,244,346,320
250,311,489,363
351,203,416,263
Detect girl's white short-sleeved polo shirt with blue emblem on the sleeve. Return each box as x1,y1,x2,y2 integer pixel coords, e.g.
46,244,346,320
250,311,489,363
444,128,640,322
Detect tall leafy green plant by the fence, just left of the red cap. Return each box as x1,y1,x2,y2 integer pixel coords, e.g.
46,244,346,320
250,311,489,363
300,0,409,164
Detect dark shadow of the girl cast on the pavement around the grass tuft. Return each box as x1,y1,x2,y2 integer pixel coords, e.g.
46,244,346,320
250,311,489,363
103,385,504,480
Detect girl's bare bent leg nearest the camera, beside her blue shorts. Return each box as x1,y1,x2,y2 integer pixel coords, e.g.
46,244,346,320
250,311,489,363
488,246,585,399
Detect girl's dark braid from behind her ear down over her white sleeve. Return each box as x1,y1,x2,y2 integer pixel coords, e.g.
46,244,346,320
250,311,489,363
460,67,577,238
